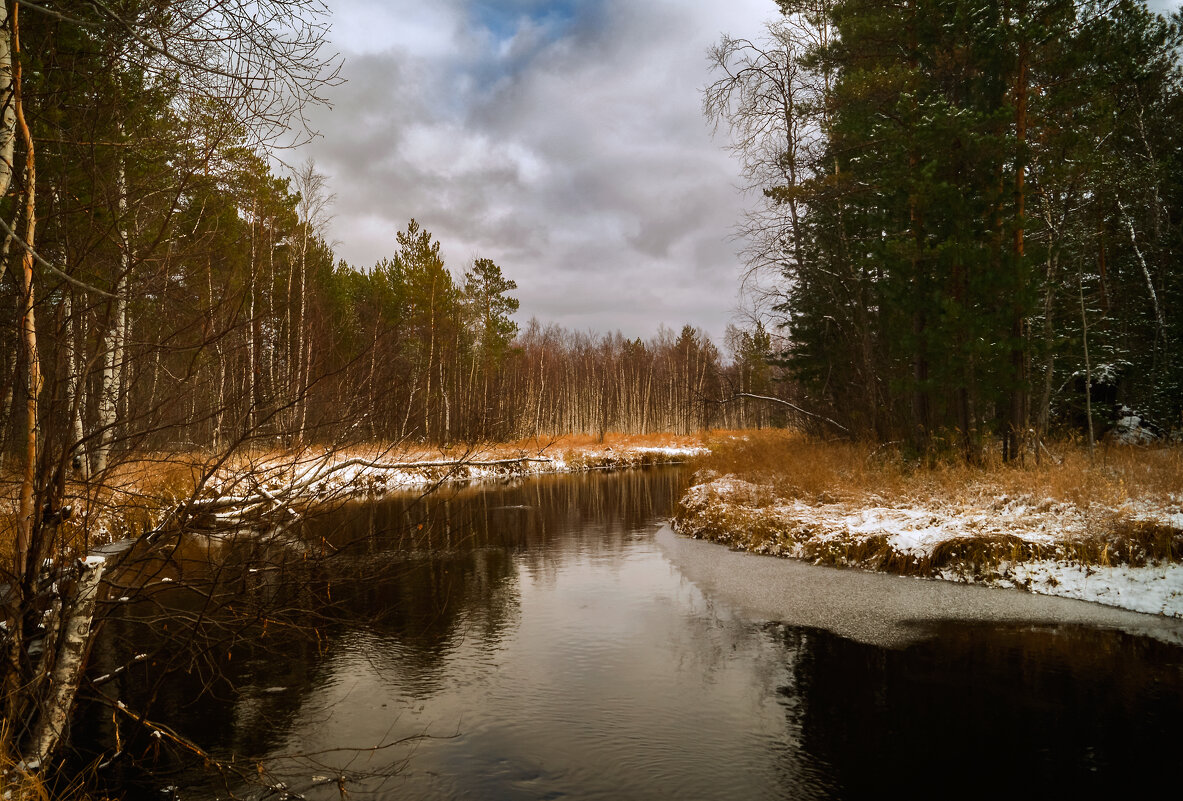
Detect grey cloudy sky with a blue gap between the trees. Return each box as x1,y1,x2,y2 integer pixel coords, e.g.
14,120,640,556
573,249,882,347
299,0,1178,337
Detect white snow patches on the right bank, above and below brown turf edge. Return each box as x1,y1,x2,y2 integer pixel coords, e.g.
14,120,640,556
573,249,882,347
675,471,1183,618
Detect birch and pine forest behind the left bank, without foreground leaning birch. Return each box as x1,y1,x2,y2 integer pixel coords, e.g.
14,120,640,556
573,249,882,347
0,4,771,486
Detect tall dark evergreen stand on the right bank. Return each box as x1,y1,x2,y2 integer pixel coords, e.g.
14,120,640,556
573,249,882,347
705,0,1183,460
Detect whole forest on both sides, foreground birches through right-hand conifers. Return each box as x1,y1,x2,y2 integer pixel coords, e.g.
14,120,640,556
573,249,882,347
0,0,1183,795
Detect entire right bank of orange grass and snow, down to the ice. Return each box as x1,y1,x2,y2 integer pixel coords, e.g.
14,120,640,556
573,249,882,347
674,431,1183,616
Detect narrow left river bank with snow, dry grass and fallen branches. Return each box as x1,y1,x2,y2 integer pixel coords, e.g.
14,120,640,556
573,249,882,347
0,433,706,554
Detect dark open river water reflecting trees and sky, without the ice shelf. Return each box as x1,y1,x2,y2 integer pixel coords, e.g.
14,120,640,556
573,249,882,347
79,469,1183,799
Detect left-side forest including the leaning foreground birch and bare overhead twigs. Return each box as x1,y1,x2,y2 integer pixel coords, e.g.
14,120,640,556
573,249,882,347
0,0,783,780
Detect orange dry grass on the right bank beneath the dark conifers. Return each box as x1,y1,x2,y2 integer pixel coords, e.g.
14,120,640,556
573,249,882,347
677,431,1183,579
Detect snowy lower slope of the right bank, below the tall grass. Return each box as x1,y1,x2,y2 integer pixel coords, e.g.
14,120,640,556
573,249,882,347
675,471,1183,616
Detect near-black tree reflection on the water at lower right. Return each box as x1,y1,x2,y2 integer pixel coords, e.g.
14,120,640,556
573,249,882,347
776,624,1183,797
